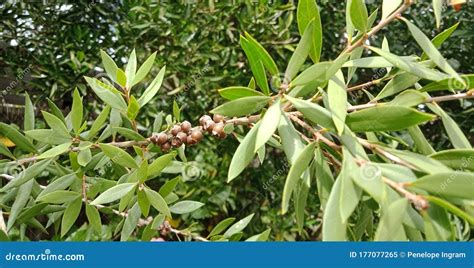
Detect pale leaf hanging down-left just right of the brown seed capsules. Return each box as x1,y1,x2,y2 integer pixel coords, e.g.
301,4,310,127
227,122,260,182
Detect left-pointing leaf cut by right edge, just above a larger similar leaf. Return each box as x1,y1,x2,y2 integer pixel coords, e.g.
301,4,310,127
430,149,474,171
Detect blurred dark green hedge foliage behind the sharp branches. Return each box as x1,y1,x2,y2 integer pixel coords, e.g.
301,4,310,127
0,1,474,240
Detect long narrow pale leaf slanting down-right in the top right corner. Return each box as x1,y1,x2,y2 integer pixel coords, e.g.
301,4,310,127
402,18,464,83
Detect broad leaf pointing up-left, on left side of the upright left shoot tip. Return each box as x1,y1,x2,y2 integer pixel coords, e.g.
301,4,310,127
84,76,127,111
